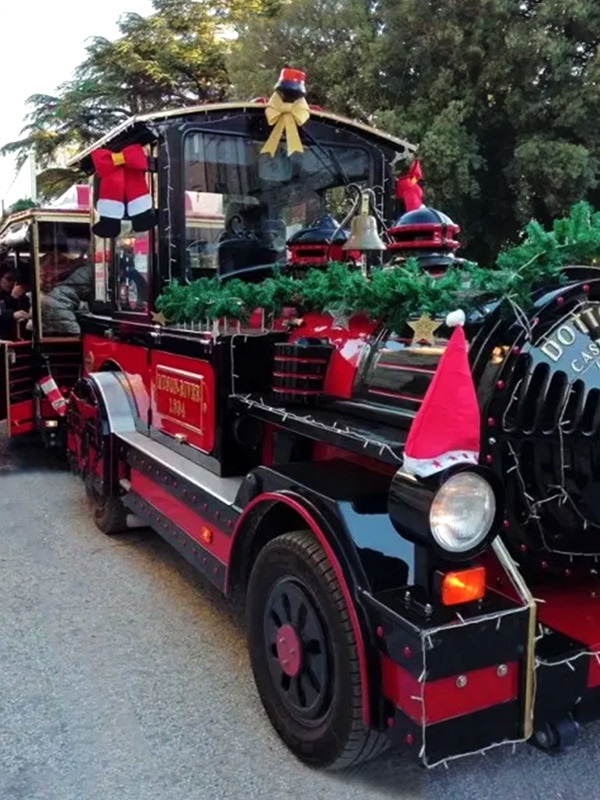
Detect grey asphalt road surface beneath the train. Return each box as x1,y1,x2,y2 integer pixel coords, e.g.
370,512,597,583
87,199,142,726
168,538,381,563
0,438,600,800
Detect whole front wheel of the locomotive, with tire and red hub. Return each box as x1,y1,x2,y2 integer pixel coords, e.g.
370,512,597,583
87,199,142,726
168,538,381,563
246,531,387,769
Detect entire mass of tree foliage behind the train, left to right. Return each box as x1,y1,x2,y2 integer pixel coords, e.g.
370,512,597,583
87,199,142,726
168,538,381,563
0,0,600,264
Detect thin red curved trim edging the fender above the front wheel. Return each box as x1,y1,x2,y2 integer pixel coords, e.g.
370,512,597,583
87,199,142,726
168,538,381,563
232,492,371,725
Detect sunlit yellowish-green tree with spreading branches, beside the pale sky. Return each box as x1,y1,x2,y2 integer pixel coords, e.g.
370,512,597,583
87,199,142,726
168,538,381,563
0,0,272,198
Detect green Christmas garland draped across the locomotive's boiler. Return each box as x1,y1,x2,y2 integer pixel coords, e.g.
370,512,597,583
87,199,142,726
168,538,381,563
157,203,600,330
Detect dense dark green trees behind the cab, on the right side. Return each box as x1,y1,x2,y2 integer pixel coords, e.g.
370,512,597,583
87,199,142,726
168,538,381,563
230,0,600,263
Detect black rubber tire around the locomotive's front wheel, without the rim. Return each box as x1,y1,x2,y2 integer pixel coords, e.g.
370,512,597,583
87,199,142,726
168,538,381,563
246,531,388,770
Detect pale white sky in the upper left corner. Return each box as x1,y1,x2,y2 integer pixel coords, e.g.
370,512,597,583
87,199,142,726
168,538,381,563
0,0,153,206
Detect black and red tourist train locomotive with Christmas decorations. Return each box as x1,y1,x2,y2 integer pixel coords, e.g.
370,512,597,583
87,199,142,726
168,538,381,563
5,70,600,768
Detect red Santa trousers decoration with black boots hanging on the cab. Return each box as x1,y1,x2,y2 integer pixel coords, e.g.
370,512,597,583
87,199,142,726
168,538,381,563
91,144,156,239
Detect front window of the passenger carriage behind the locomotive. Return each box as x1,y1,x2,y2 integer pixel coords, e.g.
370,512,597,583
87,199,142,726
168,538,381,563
38,220,94,337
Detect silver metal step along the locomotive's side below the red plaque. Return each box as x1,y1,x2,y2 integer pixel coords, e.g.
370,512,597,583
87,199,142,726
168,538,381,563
115,431,244,506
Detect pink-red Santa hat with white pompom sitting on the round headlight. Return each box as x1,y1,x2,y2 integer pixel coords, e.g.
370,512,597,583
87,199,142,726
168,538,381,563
404,311,481,478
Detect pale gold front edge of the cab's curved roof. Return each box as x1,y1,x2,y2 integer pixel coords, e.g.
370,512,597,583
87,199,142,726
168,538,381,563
68,101,417,166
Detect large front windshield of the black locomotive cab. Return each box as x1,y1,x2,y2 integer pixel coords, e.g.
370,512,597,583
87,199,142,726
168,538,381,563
184,126,375,279
